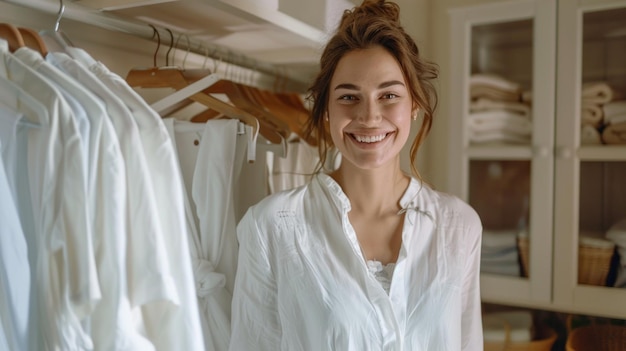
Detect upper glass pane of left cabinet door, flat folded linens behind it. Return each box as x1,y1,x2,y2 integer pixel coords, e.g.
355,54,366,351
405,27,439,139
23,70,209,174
468,20,533,144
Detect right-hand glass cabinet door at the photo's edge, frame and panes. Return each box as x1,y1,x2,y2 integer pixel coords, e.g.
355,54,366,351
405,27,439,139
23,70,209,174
555,1,626,318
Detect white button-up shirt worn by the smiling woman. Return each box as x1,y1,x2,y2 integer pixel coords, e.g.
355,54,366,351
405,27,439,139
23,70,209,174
230,174,483,351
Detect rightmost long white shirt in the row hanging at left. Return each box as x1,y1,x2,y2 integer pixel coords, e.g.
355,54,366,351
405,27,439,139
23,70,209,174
79,48,204,351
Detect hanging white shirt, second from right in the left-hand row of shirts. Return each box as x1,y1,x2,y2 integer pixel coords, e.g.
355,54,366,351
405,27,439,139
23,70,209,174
49,53,180,349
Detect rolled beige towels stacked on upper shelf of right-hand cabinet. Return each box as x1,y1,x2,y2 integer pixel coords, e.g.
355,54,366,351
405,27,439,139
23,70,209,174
580,82,626,144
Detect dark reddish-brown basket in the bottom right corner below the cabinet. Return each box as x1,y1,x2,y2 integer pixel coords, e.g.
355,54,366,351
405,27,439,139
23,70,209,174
565,324,626,351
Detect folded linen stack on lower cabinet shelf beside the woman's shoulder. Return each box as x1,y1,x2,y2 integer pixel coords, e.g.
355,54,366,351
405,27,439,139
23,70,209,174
480,230,520,277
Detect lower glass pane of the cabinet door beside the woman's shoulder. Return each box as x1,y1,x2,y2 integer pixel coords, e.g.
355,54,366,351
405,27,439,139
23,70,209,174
469,160,530,276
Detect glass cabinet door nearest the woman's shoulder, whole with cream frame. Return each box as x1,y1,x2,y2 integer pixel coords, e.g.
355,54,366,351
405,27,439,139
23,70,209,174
451,1,556,305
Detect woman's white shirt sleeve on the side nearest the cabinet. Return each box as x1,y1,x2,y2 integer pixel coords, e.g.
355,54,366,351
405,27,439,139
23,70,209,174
461,206,483,351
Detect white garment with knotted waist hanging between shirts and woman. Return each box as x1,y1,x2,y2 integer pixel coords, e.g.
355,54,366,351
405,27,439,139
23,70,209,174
165,118,247,351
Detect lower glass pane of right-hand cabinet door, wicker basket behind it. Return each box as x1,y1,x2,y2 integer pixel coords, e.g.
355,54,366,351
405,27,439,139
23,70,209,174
578,161,626,288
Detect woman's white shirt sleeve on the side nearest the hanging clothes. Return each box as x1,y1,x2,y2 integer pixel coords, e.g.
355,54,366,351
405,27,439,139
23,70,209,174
229,209,281,351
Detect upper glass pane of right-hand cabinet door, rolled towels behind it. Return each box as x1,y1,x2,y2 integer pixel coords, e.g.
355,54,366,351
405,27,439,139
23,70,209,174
581,8,626,145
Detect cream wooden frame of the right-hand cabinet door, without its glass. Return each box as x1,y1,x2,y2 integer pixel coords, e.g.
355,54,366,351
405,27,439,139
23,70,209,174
554,0,626,318
